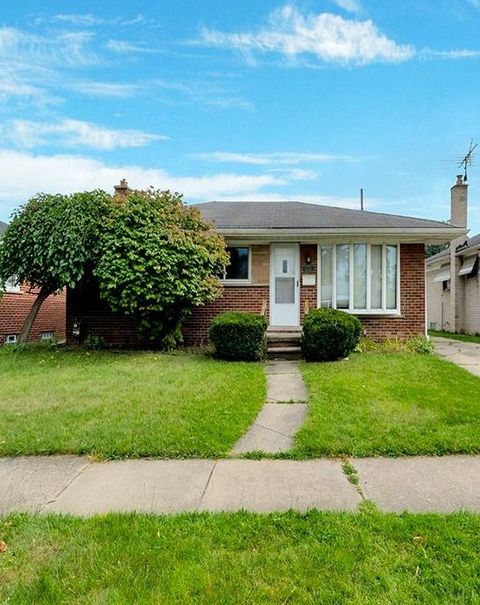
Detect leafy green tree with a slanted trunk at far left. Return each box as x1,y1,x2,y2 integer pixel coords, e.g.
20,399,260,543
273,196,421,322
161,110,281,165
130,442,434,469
0,190,112,343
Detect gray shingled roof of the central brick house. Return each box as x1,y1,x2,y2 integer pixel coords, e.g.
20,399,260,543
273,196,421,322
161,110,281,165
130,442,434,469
195,202,458,229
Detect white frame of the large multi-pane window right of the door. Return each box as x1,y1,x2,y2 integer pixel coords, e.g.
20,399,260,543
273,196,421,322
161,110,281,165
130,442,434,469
317,241,401,315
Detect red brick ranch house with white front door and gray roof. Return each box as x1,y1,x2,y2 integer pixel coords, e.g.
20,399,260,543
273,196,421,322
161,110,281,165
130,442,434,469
67,189,465,346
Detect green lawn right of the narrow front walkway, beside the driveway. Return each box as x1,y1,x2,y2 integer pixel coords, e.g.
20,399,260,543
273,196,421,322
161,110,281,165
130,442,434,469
292,353,480,458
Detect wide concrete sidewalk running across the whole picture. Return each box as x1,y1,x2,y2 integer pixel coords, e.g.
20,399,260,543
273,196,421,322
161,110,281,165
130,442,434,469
0,456,480,516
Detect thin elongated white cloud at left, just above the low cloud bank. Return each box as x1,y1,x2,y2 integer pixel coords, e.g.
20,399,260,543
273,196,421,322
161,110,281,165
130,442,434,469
0,119,168,150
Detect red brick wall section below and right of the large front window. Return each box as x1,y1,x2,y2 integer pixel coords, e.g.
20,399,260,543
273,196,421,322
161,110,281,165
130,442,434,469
360,244,425,340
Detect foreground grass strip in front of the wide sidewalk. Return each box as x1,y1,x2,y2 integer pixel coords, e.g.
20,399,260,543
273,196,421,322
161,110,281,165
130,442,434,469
0,509,480,605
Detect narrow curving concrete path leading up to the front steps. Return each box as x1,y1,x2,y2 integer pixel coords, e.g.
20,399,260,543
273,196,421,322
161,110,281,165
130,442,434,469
232,361,307,454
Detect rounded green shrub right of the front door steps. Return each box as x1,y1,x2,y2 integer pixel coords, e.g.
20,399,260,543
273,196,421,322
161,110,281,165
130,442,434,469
302,309,362,361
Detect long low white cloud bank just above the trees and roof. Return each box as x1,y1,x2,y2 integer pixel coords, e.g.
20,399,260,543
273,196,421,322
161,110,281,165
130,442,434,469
0,150,364,220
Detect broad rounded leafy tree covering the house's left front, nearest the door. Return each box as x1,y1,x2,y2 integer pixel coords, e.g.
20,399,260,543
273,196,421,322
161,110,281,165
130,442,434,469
94,190,228,348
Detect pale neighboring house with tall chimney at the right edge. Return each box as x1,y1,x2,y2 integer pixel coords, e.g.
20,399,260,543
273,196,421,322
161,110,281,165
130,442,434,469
426,176,480,334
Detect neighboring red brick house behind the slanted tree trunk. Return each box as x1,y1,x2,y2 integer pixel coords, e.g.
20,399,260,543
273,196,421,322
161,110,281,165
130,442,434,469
0,221,66,345
